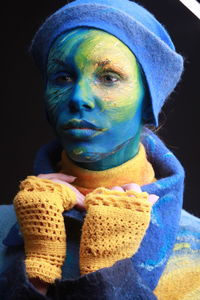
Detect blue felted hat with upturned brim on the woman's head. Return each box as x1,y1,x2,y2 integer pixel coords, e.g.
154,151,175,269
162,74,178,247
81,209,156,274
30,0,183,125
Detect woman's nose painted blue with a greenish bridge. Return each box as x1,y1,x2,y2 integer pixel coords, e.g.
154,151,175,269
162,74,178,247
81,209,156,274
69,81,95,112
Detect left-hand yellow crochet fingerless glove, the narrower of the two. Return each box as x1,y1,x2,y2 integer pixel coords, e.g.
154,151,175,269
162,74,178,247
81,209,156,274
14,176,76,283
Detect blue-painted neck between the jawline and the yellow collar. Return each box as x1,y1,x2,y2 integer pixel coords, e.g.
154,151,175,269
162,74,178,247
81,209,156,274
74,132,140,171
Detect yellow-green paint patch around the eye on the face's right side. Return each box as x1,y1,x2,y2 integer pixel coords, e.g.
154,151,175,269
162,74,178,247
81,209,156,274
75,30,144,122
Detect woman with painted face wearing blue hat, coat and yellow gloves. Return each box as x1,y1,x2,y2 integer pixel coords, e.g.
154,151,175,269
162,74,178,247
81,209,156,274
0,0,200,299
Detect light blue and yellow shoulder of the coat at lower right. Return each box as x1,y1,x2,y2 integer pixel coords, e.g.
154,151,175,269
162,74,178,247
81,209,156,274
155,212,200,300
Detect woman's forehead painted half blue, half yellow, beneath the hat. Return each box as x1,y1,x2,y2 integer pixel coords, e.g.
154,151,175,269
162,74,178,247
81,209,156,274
49,28,135,63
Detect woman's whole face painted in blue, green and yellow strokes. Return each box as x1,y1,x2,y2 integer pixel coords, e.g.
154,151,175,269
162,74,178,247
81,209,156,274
45,28,144,162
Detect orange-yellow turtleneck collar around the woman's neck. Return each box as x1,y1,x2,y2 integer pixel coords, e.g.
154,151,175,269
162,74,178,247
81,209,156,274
57,144,155,195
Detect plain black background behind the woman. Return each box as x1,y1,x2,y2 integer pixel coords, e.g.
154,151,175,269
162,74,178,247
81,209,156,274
0,0,200,216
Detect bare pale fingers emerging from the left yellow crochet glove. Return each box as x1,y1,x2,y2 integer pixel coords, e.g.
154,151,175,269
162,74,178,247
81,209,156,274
38,173,85,209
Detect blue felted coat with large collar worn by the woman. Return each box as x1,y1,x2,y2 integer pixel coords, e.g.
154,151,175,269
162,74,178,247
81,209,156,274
0,130,200,300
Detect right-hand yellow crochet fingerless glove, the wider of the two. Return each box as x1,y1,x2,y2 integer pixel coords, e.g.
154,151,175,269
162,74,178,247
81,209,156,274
80,188,152,275
